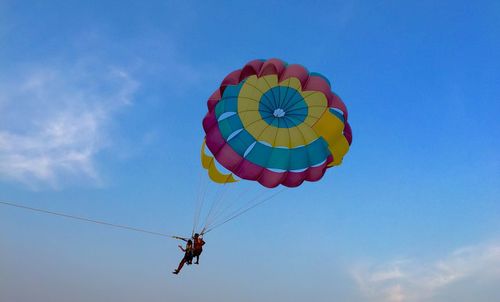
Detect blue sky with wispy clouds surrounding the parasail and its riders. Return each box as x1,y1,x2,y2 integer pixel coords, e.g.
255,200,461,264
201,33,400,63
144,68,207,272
0,1,500,302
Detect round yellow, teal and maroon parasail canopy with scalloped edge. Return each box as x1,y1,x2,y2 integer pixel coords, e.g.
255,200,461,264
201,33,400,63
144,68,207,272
201,59,352,188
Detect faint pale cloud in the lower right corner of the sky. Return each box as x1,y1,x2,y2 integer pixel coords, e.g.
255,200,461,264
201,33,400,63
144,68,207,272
352,244,500,302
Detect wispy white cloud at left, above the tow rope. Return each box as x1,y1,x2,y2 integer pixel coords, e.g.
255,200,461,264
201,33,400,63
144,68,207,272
0,62,138,187
